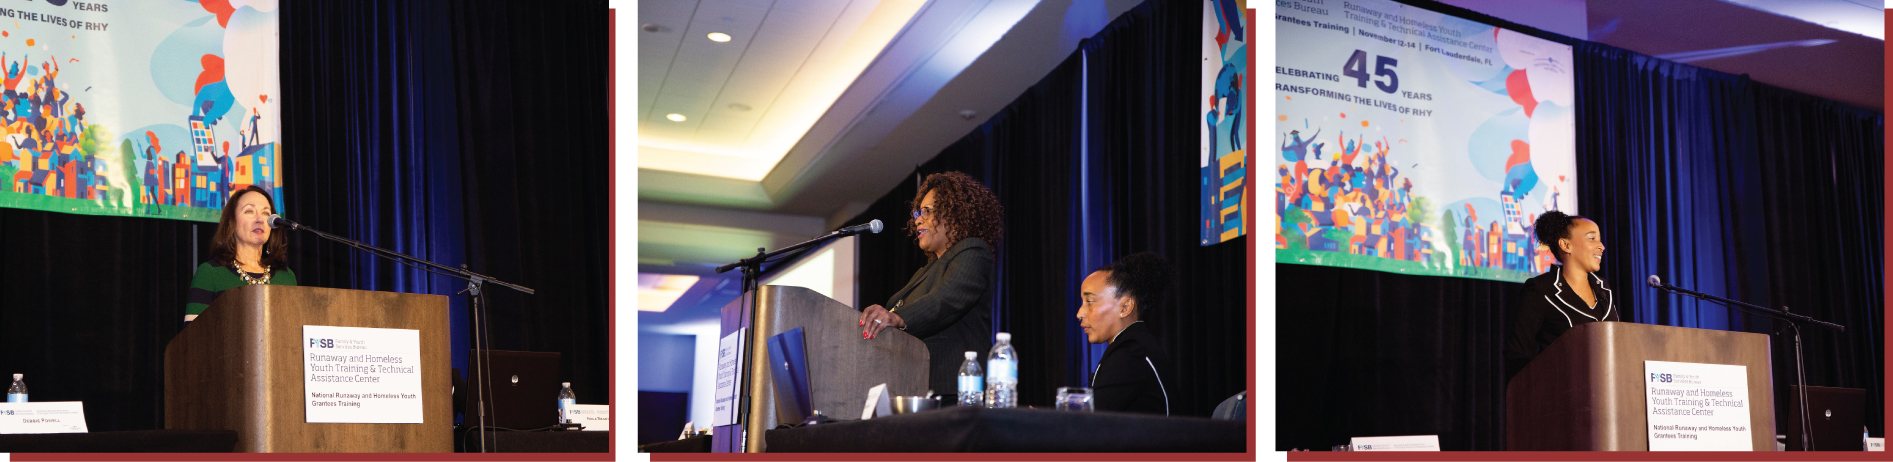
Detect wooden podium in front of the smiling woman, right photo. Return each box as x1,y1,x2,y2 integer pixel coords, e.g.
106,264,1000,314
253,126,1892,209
1505,322,1776,451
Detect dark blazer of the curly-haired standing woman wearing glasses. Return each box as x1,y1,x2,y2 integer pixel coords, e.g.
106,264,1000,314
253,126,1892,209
882,237,994,401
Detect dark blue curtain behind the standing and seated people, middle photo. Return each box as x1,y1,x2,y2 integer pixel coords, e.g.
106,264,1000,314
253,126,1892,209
850,2,1249,417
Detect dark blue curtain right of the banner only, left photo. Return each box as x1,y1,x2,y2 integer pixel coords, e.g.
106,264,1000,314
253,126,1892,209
282,0,611,418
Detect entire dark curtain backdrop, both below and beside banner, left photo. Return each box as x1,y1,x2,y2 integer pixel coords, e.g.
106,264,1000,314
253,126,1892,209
0,0,610,432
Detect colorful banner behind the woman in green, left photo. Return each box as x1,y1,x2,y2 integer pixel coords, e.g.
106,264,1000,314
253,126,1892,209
0,0,282,222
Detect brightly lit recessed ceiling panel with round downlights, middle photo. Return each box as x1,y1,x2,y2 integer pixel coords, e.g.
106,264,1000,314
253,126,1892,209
638,0,922,182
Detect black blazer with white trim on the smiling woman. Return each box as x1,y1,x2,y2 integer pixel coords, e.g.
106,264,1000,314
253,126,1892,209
1505,265,1630,382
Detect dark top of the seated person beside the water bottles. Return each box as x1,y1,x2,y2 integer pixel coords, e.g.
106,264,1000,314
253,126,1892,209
1090,322,1177,415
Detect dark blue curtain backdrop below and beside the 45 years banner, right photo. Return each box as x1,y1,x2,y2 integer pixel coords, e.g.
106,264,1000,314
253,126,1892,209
1276,0,1885,451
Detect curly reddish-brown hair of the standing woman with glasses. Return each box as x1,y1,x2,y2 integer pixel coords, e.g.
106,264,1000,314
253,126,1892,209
907,172,1005,259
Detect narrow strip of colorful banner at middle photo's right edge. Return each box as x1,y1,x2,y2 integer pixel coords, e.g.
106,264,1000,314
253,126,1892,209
1198,0,1255,246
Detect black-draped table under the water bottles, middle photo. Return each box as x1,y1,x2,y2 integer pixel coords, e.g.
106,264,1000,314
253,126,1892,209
638,407,1249,453
